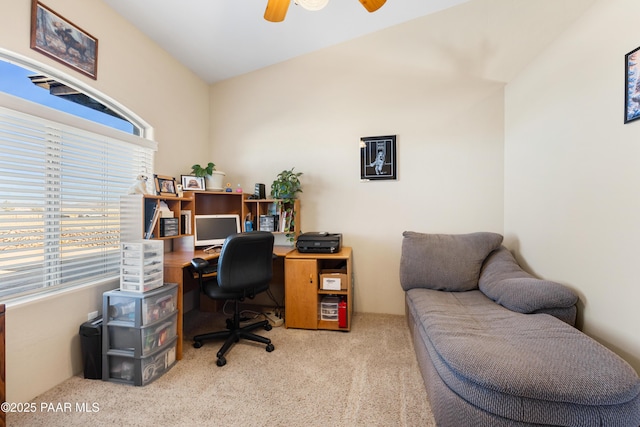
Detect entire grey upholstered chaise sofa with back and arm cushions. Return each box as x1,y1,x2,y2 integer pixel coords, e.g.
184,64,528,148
400,232,640,427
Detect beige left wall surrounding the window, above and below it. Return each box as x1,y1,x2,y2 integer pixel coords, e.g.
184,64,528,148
0,0,209,402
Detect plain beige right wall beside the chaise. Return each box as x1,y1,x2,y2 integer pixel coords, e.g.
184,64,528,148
505,0,640,371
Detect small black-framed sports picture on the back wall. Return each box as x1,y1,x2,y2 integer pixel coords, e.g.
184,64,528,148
360,135,398,181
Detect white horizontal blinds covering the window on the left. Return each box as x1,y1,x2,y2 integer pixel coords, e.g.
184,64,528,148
0,94,155,301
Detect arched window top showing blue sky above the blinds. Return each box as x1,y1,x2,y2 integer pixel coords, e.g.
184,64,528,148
0,49,152,139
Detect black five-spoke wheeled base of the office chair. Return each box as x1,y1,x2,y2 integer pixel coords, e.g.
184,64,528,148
193,300,275,366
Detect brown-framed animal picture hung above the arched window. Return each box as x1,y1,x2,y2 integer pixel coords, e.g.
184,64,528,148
31,0,98,80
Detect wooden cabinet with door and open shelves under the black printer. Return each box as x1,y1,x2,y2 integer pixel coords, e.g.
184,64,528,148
284,247,354,331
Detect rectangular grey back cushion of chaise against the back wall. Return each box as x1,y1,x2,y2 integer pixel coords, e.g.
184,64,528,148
400,231,502,291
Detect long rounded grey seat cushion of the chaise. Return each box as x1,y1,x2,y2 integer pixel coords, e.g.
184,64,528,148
406,289,640,426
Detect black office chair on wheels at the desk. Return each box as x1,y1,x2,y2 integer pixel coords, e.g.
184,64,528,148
191,231,275,366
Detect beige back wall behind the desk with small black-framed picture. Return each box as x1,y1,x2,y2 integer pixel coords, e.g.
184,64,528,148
211,0,592,314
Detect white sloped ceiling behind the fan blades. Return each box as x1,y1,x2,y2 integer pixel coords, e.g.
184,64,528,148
103,0,468,83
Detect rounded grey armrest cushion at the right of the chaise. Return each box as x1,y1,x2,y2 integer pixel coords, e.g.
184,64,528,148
479,247,578,313
